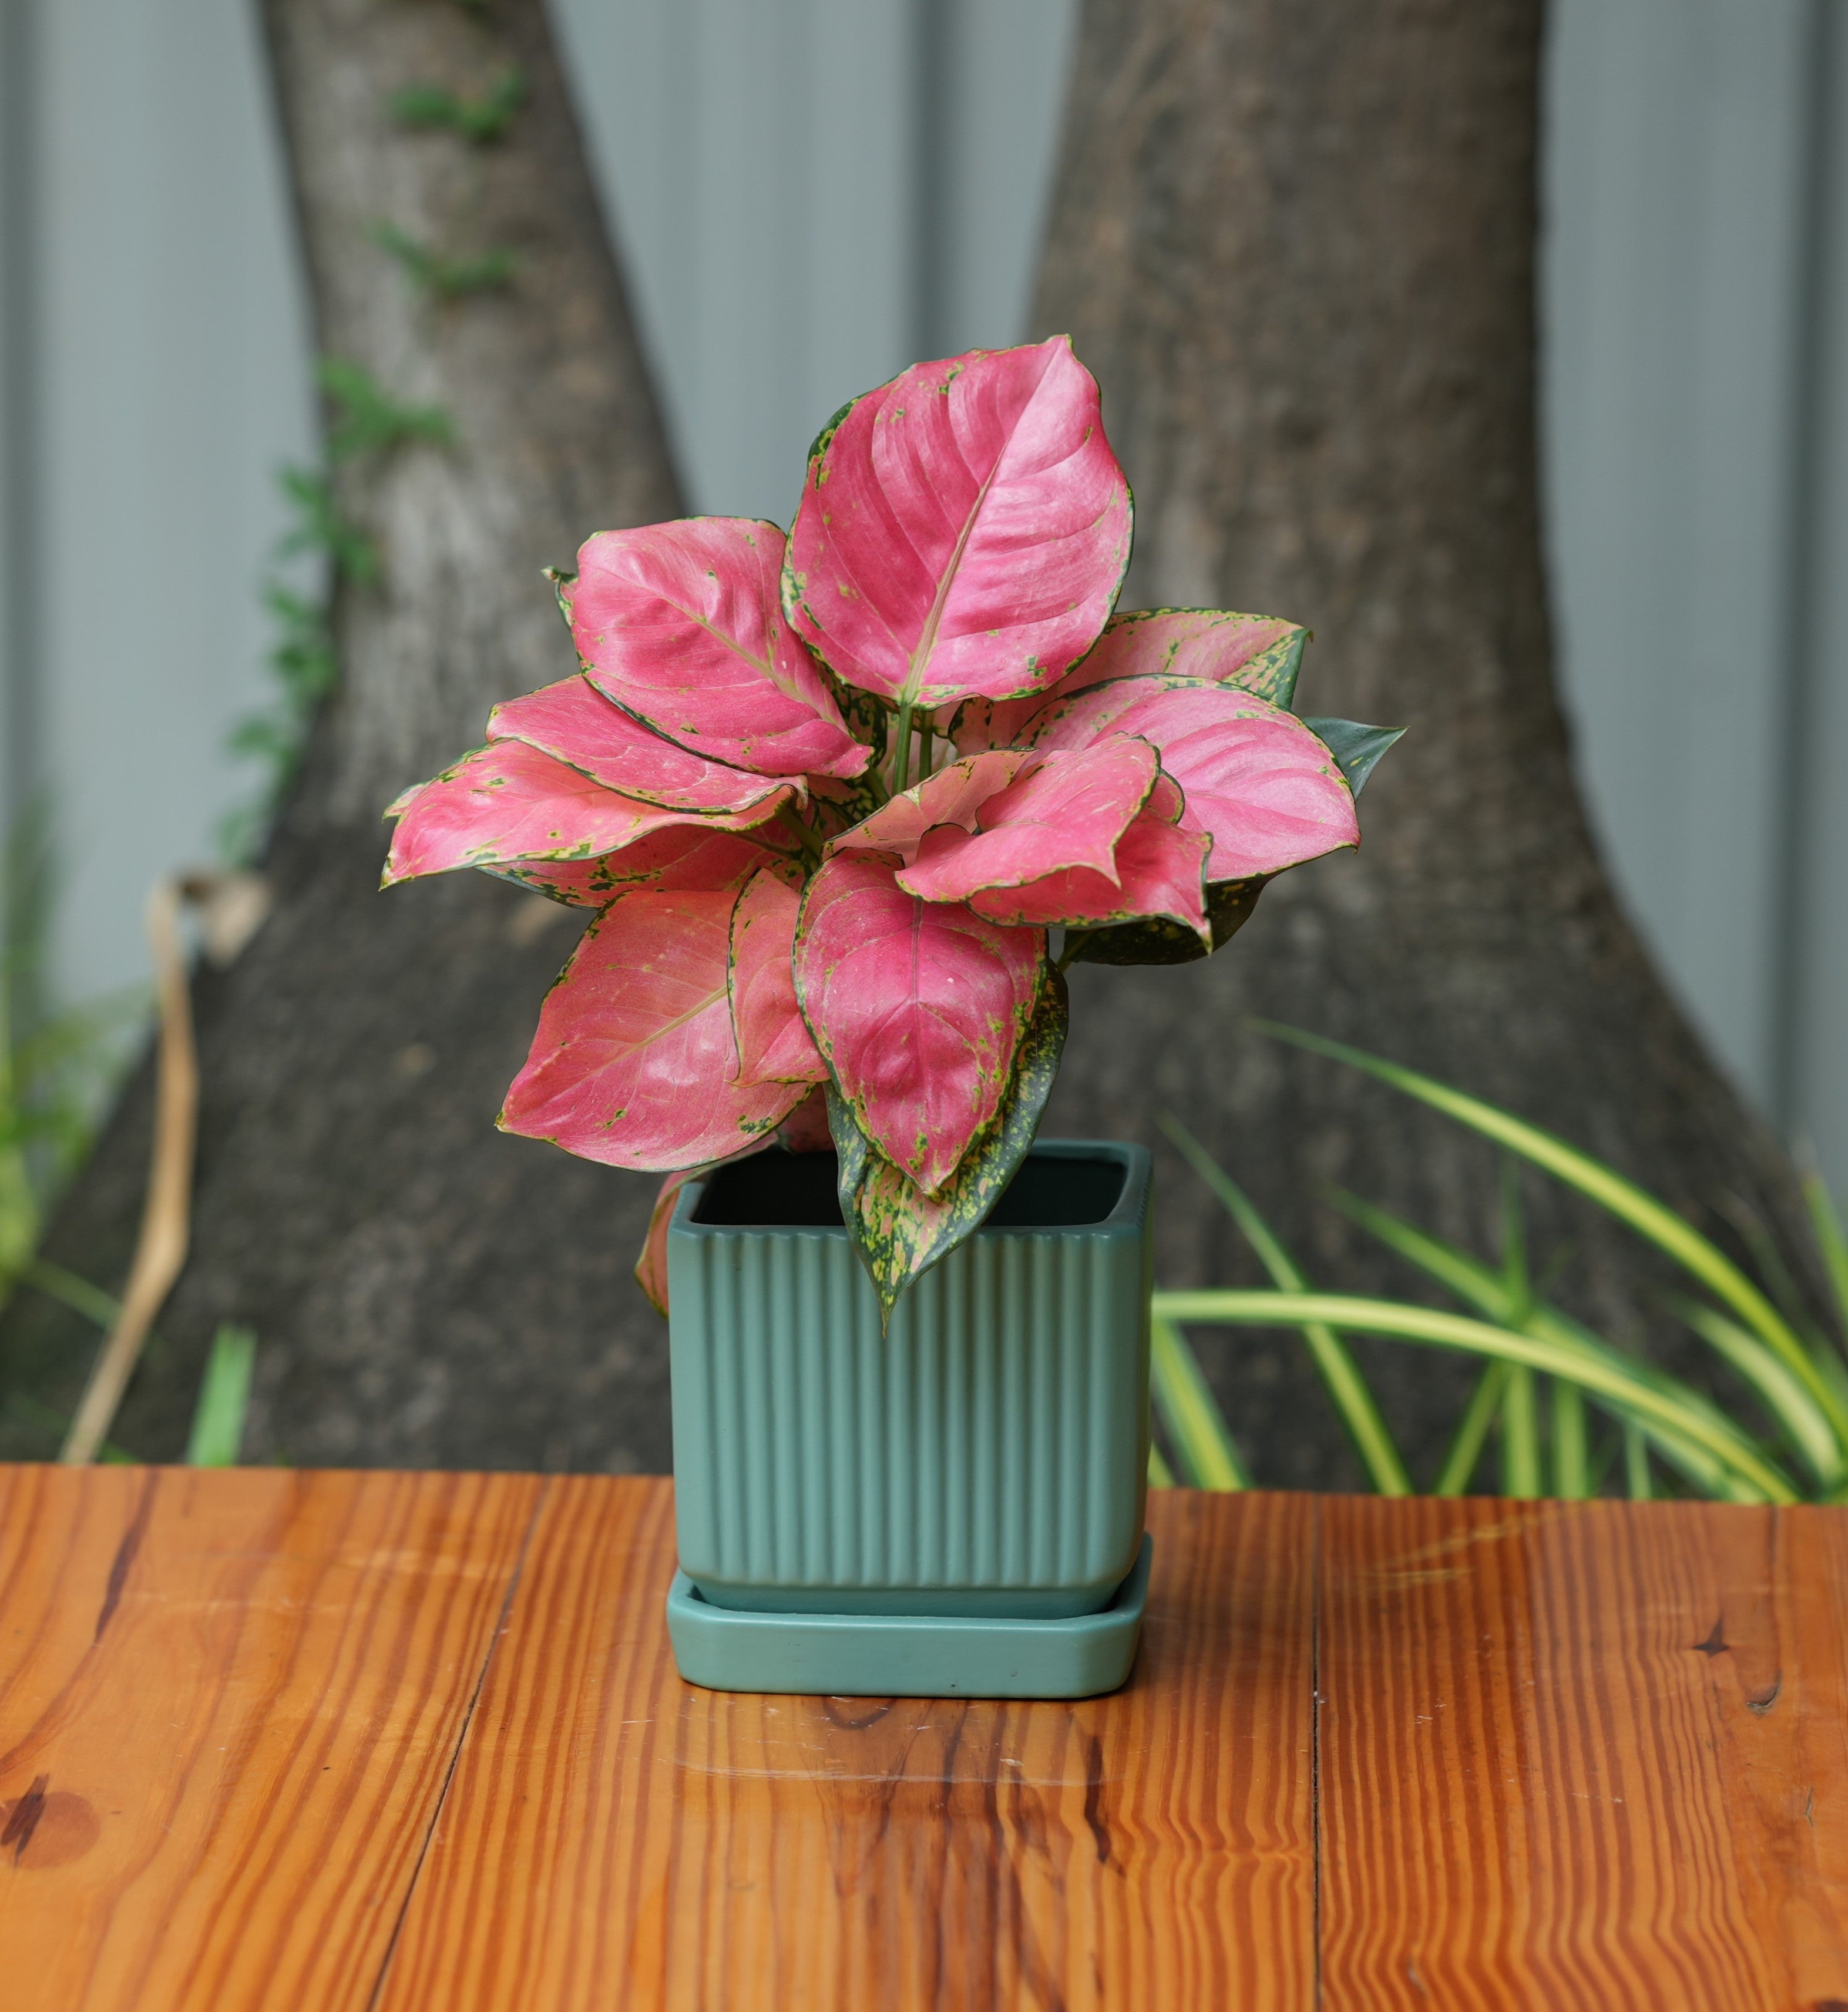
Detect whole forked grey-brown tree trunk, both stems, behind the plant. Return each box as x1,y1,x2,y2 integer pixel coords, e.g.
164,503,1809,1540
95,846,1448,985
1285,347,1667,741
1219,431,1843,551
0,0,1817,1481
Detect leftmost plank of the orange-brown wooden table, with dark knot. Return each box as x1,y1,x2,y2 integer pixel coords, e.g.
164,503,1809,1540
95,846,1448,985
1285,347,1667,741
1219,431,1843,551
0,1467,541,2012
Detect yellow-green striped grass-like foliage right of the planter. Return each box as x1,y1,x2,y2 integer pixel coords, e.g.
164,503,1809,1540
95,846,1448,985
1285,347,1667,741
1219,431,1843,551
1153,1026,1848,1503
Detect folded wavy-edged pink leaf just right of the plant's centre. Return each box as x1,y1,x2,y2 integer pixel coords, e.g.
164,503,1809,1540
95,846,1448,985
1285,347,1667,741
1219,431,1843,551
899,734,1156,913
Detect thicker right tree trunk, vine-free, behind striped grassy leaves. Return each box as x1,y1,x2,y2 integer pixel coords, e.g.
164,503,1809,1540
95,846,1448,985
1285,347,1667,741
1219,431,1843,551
1036,0,1804,1483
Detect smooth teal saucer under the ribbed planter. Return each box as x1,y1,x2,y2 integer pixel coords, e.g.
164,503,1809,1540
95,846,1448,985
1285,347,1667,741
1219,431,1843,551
668,1535,1154,1698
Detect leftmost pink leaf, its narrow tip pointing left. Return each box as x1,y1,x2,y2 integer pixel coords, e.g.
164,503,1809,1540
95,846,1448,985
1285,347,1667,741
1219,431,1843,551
380,740,790,887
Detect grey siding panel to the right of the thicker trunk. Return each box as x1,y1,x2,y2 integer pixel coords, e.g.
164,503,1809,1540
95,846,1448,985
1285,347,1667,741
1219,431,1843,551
1544,0,1812,1104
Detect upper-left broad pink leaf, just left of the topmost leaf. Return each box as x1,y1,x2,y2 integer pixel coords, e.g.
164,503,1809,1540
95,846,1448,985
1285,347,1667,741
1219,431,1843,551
559,517,871,777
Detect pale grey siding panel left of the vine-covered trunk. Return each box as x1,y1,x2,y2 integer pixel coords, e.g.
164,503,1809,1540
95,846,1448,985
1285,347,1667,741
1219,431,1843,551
25,0,314,998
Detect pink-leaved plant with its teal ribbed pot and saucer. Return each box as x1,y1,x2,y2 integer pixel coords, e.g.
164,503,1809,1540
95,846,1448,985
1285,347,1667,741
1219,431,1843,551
384,338,1393,1694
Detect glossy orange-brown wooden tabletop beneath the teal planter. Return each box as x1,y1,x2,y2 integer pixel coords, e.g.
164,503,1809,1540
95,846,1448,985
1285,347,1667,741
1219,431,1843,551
0,1467,1848,2012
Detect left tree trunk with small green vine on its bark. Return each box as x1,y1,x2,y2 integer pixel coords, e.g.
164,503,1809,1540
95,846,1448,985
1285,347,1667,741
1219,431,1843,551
0,0,680,1469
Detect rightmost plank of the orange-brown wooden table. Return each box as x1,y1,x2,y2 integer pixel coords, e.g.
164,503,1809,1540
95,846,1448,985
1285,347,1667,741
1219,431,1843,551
1317,1499,1848,2012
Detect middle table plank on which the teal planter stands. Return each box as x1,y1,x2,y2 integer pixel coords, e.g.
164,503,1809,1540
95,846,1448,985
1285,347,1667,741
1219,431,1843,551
380,1479,1315,2012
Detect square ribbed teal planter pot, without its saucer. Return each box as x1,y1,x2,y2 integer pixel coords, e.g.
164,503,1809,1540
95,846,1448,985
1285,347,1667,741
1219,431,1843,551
668,1141,1150,1694
